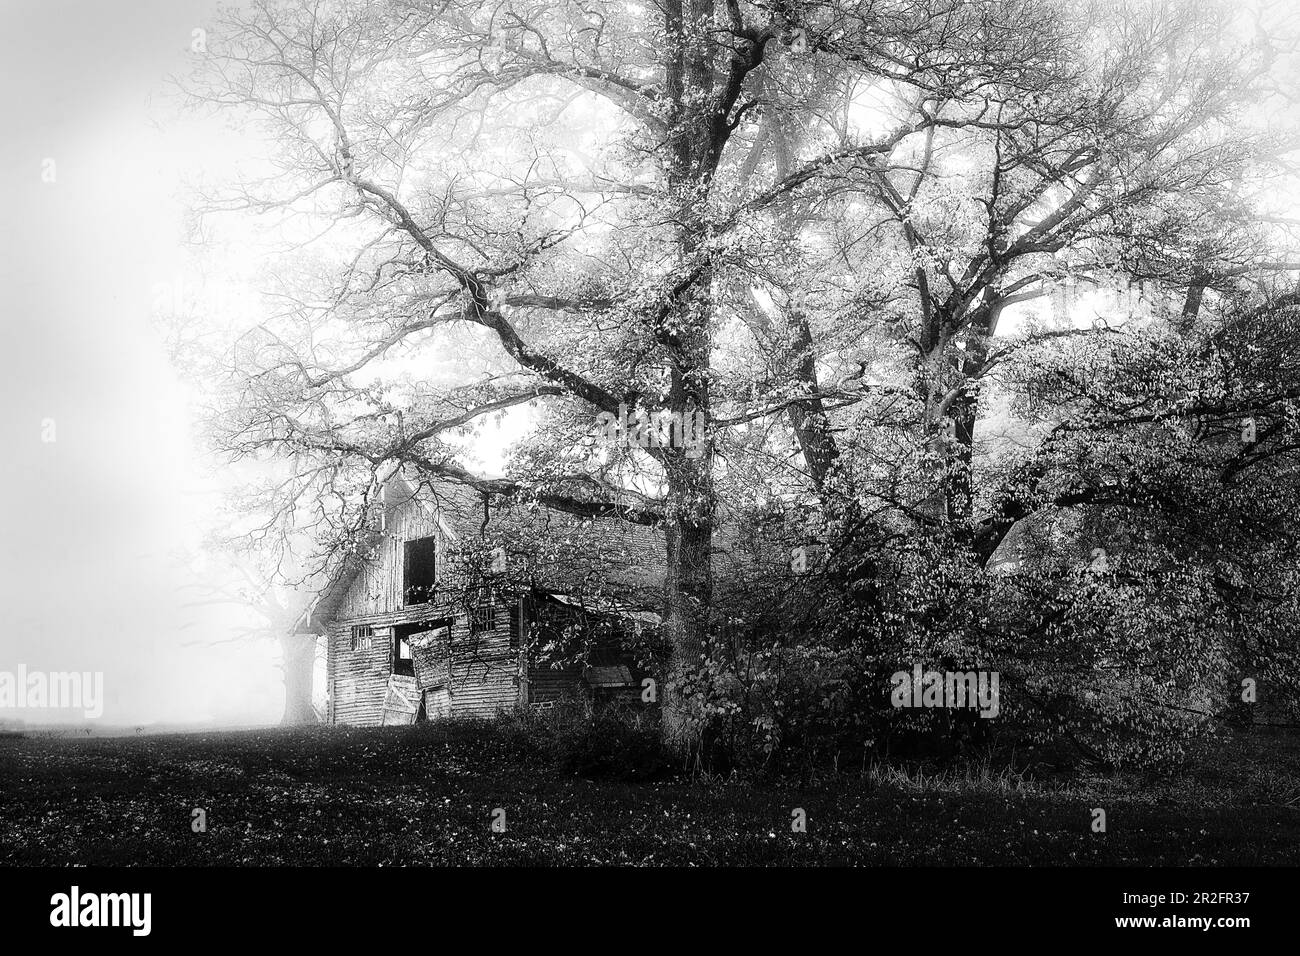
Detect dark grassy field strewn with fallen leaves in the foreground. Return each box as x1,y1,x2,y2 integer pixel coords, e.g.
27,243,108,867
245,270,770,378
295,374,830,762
0,723,1300,866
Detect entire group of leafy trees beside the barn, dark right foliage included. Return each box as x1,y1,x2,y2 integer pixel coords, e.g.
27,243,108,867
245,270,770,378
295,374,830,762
180,0,1300,753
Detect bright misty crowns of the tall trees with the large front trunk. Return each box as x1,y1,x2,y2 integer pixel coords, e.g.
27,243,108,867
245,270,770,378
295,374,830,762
185,0,1287,764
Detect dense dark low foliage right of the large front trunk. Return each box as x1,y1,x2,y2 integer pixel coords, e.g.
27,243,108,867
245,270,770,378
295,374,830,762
697,299,1300,765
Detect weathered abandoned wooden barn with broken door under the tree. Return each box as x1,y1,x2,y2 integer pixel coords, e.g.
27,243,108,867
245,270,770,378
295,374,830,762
299,473,663,726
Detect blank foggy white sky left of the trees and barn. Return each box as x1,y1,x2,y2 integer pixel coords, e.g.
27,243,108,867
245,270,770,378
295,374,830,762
0,0,292,724
